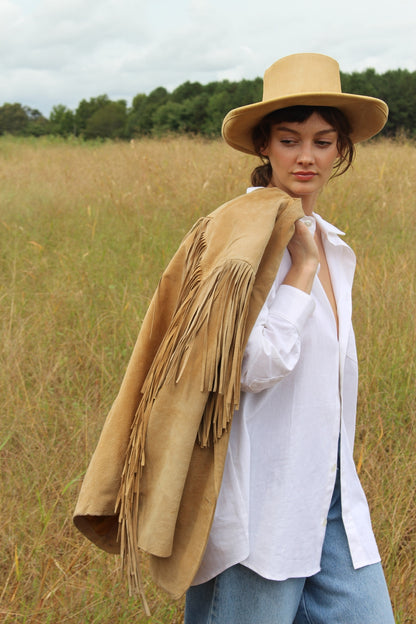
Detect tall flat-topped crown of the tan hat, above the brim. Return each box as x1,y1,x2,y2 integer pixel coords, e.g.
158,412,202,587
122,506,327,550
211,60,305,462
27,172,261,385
263,54,341,102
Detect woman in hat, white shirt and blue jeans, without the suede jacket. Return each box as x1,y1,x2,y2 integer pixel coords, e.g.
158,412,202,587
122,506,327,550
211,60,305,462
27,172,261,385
185,55,394,624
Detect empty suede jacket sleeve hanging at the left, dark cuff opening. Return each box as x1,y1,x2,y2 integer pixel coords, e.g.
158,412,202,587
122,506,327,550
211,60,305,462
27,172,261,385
73,234,192,553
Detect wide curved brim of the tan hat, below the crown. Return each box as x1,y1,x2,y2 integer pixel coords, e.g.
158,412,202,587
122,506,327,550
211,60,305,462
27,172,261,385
222,92,388,154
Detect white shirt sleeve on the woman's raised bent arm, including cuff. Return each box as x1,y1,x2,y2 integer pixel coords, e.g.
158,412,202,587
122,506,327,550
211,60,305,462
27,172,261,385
241,284,315,392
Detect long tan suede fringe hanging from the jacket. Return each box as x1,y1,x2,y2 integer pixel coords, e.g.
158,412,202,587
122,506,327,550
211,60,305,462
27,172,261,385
116,218,255,604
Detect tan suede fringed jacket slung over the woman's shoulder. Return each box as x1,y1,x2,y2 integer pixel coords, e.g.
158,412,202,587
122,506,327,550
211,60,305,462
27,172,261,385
74,188,303,598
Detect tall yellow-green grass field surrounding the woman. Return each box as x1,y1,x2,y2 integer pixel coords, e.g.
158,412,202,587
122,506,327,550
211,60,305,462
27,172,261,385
0,137,416,624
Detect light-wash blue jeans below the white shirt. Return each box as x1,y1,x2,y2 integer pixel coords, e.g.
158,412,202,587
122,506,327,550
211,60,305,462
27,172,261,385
185,471,394,624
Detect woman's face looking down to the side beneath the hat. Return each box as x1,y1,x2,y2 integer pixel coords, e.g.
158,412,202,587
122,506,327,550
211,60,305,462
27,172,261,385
262,112,339,210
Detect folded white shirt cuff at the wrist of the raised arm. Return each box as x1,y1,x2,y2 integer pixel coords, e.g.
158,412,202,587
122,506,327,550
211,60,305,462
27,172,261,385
269,284,315,333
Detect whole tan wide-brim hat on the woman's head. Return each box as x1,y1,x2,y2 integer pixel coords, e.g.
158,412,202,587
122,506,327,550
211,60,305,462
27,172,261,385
222,53,388,154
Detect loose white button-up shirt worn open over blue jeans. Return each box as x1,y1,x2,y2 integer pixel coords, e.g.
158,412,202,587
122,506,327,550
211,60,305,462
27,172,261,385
194,214,380,584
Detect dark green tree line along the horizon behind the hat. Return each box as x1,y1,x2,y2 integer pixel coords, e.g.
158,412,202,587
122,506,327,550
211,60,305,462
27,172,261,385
0,69,416,139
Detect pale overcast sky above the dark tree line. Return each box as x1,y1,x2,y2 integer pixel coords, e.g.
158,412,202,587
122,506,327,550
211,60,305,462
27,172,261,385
0,0,416,115
